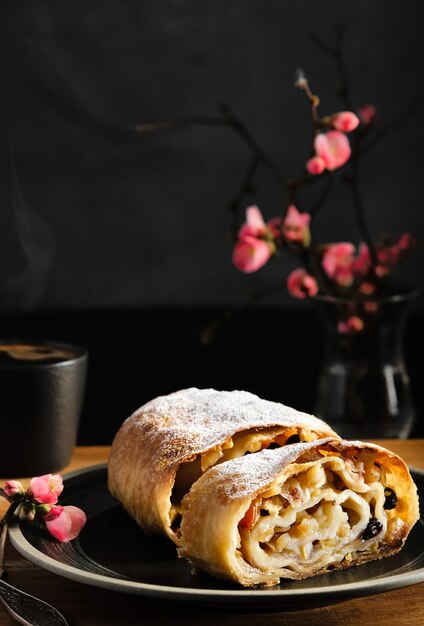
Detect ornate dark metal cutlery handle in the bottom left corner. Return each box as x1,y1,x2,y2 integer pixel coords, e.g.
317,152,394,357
0,579,68,626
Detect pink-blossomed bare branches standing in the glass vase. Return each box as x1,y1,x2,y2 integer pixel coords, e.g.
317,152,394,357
132,26,416,332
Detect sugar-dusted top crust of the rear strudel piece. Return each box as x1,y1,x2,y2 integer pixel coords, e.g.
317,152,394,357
121,387,335,469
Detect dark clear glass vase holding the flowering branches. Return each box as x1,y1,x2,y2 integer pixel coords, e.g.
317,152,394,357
315,291,418,439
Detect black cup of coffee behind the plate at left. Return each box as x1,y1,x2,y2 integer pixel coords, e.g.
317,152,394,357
0,340,88,478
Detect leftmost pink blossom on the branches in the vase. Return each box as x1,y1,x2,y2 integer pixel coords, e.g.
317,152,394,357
232,206,275,274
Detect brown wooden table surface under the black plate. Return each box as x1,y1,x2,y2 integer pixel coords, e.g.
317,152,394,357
0,439,424,626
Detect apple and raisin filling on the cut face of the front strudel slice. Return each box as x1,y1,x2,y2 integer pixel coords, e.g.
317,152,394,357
237,452,404,578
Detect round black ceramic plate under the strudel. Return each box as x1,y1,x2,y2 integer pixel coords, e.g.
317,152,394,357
10,466,424,608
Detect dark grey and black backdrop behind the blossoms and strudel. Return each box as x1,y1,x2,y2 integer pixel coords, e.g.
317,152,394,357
0,0,424,443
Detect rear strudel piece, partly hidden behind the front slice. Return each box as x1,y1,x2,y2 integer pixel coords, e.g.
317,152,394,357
108,388,337,541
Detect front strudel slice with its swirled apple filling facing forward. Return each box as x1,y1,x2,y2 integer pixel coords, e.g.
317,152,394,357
178,439,419,587
